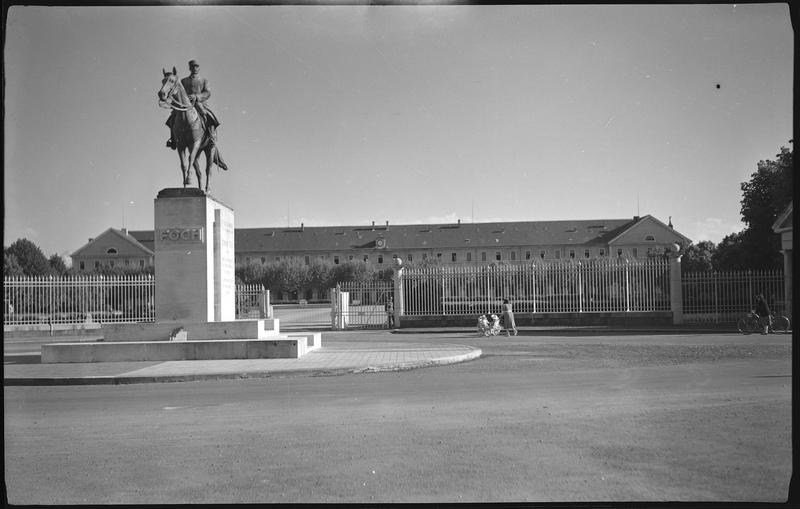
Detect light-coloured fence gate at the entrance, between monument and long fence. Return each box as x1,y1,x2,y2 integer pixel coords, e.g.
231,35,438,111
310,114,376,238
331,281,394,329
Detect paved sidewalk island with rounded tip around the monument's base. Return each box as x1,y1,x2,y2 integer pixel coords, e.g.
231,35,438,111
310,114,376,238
3,334,482,386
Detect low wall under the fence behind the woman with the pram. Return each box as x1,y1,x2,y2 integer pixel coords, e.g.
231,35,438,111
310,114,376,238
401,311,673,329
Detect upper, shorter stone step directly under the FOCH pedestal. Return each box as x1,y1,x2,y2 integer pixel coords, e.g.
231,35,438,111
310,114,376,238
101,318,281,342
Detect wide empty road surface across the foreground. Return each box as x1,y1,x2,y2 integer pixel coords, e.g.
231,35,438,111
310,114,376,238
4,331,792,504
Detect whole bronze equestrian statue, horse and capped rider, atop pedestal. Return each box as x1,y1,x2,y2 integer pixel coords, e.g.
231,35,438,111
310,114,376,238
158,60,228,193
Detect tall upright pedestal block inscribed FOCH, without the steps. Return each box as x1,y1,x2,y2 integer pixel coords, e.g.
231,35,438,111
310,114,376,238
154,188,236,323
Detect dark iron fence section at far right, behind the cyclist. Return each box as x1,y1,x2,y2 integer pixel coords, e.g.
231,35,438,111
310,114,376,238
681,270,787,322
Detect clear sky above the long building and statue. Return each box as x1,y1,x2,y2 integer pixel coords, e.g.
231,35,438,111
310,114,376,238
3,4,794,264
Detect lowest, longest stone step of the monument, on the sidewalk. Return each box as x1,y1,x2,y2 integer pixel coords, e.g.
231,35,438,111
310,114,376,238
42,332,322,364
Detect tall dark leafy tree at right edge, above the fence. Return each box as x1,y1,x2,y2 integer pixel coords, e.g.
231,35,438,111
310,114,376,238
713,147,794,270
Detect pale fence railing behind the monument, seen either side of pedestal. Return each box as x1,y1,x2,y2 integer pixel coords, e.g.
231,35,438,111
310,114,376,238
3,275,271,325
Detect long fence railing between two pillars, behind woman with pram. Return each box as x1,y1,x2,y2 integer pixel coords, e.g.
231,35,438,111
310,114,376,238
403,259,670,316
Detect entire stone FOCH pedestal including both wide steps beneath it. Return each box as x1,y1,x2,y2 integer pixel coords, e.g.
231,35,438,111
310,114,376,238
42,188,322,363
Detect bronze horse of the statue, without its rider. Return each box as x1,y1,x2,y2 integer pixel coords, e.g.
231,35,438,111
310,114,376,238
158,67,228,192
